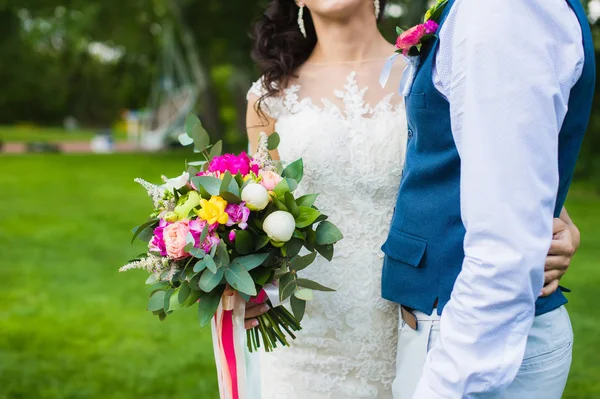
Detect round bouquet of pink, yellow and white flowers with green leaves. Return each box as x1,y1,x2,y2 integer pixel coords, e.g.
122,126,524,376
120,116,342,363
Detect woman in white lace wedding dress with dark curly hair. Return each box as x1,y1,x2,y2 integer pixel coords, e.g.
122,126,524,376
241,0,579,399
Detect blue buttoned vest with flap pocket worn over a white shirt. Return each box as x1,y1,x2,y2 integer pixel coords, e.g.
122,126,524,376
382,0,596,315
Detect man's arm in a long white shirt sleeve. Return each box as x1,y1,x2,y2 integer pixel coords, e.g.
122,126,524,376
414,0,583,399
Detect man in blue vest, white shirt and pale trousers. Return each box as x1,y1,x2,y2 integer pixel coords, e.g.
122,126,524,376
383,0,596,399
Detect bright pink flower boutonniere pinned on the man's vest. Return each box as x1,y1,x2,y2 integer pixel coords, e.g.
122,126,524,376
396,0,448,56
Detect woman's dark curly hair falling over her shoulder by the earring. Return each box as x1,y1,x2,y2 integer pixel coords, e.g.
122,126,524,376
251,0,387,115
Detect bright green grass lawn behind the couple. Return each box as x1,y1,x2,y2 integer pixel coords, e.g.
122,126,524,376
0,154,600,399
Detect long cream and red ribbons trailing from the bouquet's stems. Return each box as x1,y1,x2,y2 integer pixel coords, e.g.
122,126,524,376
212,288,247,399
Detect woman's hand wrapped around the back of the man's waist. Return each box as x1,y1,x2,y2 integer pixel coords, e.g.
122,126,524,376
541,219,579,297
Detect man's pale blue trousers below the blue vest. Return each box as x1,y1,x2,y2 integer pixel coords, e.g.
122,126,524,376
393,306,573,399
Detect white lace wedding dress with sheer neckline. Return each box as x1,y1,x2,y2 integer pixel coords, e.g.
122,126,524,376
248,60,407,399
